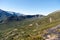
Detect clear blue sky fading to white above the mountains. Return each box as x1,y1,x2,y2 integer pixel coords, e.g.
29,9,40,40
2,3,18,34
0,0,60,15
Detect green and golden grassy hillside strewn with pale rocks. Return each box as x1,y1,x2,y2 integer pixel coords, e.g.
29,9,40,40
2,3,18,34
0,11,60,40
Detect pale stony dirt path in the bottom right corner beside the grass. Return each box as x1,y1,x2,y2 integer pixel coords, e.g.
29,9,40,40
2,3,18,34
44,25,60,40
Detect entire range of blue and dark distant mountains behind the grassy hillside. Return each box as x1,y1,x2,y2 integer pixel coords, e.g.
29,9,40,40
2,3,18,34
0,9,43,23
